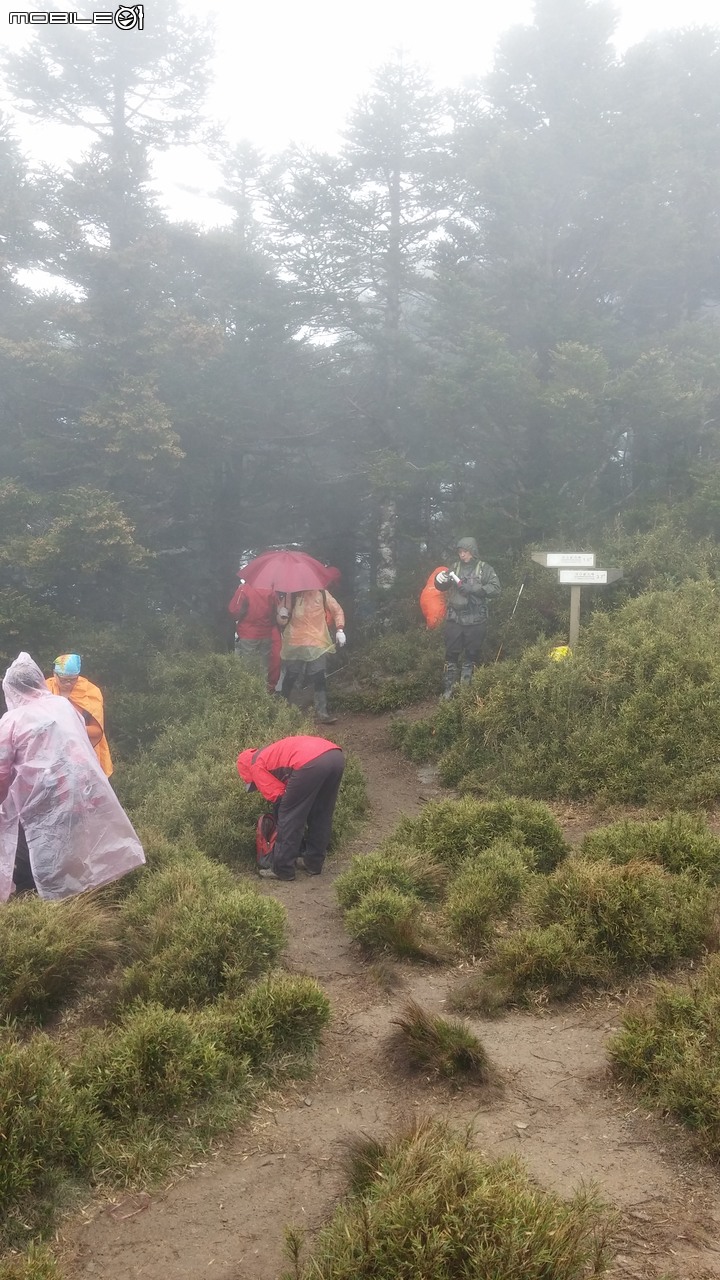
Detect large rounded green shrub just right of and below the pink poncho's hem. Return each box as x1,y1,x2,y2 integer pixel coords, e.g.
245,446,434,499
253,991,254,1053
122,858,287,1009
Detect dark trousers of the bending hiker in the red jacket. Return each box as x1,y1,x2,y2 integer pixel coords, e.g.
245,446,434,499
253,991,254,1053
273,748,345,879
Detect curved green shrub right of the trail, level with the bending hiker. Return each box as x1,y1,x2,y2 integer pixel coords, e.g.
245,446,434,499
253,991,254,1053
395,796,568,872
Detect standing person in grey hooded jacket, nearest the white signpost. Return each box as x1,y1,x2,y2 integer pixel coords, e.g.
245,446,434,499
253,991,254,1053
436,538,500,699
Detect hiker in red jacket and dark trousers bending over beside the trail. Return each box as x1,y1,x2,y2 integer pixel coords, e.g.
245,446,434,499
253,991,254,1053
237,735,345,881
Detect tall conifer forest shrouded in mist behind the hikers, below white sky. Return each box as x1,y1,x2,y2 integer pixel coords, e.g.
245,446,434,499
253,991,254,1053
0,0,720,655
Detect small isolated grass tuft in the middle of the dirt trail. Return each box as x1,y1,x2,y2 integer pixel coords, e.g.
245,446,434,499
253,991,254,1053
391,1000,489,1084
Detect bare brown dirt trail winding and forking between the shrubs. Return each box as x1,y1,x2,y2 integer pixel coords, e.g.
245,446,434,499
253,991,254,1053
65,716,720,1280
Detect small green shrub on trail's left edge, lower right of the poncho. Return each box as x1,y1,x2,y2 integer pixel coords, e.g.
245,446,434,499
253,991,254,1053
204,973,331,1070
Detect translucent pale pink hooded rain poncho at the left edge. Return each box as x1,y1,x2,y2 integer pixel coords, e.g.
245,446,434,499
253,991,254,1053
0,653,145,901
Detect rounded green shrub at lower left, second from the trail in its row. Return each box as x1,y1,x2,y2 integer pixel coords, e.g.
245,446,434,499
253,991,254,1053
69,1004,240,1125
